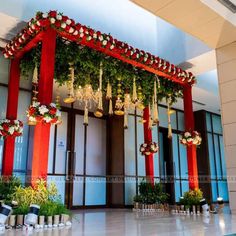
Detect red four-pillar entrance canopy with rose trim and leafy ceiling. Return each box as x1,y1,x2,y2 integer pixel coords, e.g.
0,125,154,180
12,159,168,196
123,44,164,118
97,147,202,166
2,11,198,189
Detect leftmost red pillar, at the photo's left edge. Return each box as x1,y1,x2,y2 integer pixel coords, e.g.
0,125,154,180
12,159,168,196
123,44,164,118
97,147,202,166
2,59,20,176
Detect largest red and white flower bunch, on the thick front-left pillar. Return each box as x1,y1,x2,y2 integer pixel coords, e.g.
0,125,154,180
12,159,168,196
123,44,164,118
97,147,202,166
26,102,61,124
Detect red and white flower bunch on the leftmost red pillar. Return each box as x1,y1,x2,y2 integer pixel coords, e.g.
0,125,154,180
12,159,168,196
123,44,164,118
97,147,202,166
0,119,23,138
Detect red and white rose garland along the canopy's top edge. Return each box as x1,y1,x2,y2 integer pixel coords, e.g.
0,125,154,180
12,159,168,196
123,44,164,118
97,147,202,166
3,11,195,84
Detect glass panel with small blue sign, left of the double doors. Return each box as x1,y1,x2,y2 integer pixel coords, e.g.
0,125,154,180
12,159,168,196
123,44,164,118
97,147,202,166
55,112,68,174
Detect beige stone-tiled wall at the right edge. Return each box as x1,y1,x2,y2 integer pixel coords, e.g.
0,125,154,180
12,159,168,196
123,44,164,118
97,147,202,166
216,42,236,213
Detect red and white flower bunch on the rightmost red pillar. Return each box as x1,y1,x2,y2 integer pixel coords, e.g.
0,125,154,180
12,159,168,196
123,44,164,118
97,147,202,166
180,131,202,146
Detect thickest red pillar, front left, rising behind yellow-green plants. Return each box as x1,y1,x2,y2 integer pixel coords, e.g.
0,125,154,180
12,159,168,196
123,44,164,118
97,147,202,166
31,28,56,184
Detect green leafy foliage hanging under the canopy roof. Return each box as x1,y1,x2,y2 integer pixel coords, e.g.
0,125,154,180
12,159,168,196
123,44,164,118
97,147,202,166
21,38,182,105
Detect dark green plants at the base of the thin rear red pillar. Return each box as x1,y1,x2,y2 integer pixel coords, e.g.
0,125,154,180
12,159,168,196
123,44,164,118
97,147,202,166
134,181,169,204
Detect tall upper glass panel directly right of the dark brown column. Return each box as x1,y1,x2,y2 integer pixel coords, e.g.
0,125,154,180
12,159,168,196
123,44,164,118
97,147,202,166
124,116,136,175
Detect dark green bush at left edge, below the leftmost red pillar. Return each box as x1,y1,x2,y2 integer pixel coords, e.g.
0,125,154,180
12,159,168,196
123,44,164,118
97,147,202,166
0,176,21,204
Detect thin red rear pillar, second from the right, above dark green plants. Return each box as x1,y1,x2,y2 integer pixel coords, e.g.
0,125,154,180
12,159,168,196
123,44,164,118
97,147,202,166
143,106,154,184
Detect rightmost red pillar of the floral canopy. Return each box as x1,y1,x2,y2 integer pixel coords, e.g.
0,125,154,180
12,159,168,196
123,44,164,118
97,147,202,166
184,85,199,189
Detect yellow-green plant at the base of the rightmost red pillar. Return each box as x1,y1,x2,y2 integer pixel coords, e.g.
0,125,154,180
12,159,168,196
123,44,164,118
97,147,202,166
180,189,203,206
